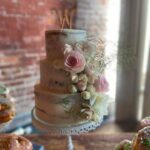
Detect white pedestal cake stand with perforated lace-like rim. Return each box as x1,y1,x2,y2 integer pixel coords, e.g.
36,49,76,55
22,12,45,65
32,108,103,150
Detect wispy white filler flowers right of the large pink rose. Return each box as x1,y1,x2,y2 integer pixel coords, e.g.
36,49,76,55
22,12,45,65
74,37,112,75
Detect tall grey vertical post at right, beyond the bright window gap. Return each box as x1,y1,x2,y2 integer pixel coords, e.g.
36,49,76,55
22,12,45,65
116,0,150,121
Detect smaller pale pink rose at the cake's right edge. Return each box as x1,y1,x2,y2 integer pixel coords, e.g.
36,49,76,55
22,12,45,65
94,76,109,92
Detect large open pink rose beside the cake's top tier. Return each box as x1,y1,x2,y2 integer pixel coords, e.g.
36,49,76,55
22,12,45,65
64,51,86,73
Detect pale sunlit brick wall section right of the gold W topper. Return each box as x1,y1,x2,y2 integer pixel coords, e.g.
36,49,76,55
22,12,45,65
76,0,110,39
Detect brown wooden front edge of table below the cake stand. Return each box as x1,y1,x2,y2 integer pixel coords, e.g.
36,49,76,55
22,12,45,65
27,132,134,150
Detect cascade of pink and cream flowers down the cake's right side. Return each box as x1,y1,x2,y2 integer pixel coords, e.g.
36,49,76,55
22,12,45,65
54,38,110,121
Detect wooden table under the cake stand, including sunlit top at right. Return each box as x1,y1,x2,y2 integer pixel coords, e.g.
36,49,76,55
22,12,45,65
27,122,137,150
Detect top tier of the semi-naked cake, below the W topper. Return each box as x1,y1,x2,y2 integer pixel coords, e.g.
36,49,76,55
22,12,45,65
45,29,86,61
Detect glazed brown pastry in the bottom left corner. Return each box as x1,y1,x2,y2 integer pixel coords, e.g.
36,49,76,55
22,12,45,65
0,134,32,150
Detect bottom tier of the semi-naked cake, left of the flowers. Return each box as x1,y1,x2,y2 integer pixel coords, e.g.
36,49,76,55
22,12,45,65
35,85,87,126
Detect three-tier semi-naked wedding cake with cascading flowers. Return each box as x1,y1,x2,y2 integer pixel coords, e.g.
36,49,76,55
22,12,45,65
35,29,108,126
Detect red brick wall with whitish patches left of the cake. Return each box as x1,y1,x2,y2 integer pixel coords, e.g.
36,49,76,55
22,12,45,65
0,0,77,127
